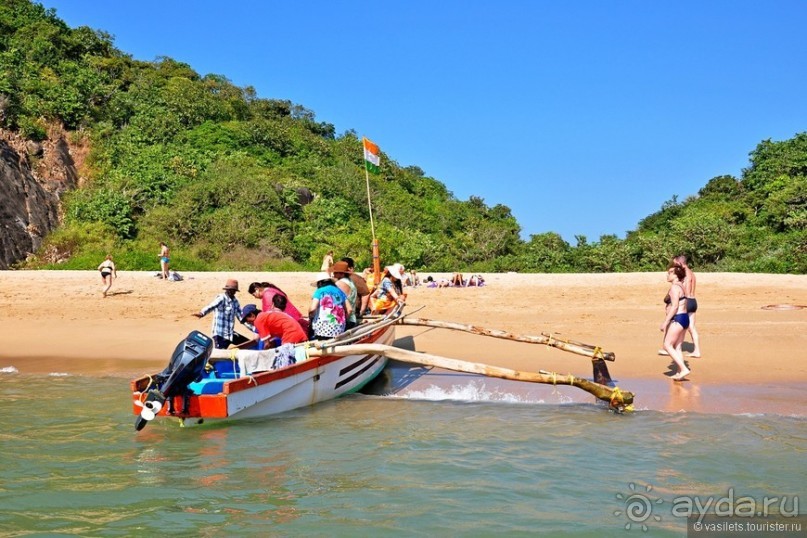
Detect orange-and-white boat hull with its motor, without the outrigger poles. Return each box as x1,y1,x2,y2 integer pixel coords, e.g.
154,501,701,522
131,308,402,430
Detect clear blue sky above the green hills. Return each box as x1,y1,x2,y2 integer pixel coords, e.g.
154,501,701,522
42,0,807,245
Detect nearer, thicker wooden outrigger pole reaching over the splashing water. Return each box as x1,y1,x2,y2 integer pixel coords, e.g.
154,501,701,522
307,344,634,412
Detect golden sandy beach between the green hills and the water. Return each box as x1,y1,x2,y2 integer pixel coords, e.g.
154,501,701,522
0,271,807,415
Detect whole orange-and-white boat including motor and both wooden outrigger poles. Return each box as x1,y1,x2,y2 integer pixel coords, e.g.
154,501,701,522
131,298,634,430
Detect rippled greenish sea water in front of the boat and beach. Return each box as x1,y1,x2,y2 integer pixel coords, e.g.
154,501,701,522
0,371,807,536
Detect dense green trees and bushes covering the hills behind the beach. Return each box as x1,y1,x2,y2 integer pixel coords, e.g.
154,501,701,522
0,0,807,273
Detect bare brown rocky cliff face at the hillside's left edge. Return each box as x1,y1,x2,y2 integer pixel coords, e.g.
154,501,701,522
0,129,79,269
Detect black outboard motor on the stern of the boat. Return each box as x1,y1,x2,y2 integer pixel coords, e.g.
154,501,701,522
135,331,213,431
